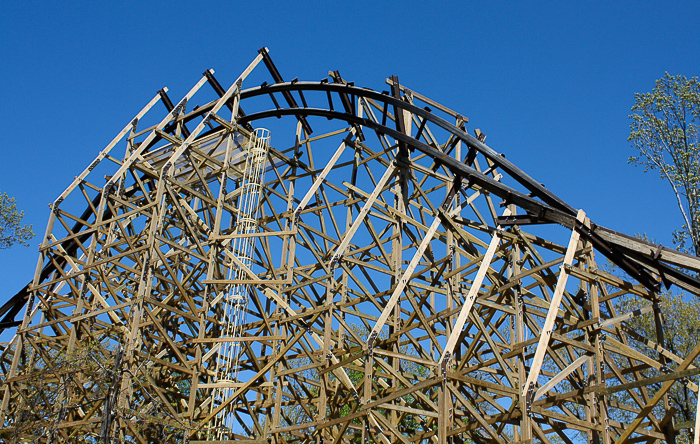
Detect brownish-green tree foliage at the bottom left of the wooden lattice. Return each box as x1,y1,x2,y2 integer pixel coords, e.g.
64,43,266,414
0,336,189,444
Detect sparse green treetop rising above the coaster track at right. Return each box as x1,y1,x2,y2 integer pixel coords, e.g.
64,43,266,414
628,73,700,256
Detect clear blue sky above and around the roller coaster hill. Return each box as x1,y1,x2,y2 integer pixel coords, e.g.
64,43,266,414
0,0,700,301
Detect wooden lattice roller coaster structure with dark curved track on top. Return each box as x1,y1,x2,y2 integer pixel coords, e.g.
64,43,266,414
0,49,700,444
